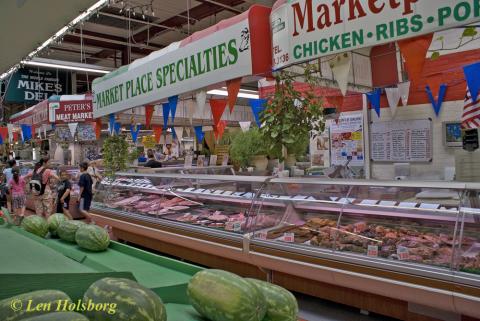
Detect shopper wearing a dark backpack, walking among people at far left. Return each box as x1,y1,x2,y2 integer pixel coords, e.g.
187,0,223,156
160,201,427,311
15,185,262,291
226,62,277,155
25,158,59,218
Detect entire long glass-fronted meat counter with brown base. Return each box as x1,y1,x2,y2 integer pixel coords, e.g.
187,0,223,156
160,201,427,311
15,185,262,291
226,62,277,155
92,173,480,320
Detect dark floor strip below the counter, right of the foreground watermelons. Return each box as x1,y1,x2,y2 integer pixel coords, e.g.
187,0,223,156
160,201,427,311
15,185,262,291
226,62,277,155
296,294,396,321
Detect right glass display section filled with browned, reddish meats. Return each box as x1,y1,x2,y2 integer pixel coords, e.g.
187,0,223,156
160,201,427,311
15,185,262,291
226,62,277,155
252,178,480,284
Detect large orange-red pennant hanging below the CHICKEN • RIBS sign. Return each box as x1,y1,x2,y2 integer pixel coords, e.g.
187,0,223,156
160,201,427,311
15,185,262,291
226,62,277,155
397,33,433,82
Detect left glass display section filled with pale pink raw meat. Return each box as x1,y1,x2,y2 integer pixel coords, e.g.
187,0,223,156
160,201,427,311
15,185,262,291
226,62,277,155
94,173,265,236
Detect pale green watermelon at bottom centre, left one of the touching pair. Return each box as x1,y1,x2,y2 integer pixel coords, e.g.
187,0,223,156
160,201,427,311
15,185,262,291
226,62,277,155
187,270,266,321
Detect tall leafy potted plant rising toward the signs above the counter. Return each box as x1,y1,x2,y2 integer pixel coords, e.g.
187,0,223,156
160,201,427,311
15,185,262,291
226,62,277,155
261,64,325,160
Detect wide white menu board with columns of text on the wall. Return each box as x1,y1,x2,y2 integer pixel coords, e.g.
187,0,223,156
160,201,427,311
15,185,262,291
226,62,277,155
370,119,432,162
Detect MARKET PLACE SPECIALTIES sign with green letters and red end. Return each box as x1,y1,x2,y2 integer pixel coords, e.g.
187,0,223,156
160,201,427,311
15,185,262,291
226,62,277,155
93,5,271,118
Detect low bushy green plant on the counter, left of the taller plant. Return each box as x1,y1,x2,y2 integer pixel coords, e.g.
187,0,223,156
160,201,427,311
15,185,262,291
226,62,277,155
230,128,267,168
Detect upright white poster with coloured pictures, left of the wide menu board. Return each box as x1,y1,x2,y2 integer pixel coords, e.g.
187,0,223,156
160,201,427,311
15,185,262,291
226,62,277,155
330,113,365,166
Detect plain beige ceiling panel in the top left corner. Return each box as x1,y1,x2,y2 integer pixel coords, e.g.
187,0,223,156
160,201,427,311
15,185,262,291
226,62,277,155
0,0,97,74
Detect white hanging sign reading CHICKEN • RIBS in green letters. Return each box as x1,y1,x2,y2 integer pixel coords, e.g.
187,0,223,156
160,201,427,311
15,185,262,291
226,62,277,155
270,0,480,69
